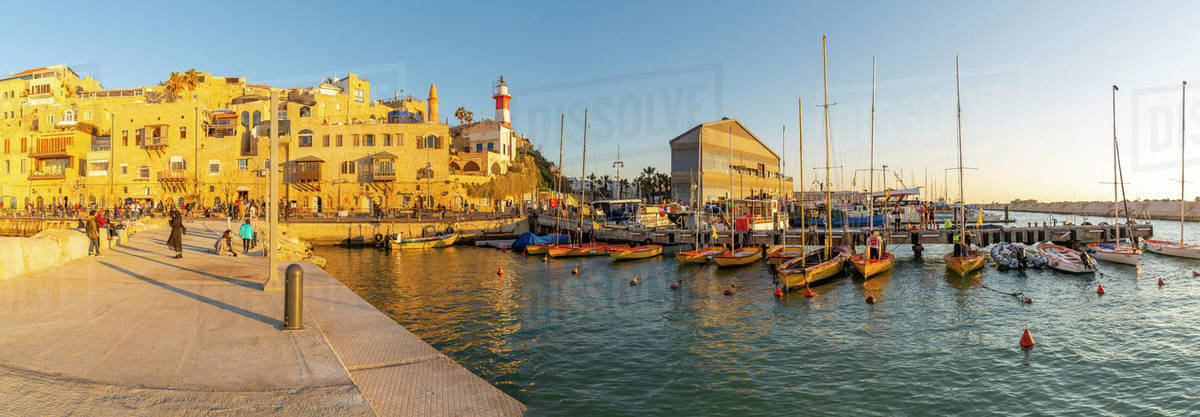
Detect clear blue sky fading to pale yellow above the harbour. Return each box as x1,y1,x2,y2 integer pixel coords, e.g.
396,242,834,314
0,1,1200,201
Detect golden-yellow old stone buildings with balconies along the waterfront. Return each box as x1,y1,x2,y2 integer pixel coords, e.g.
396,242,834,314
0,66,474,213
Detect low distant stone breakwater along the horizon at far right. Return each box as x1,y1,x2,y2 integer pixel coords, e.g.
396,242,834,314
982,201,1200,222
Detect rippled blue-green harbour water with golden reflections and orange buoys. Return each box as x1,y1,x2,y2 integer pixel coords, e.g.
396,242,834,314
316,209,1200,416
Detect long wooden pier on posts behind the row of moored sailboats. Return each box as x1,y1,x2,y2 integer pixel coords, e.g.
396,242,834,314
530,216,1154,247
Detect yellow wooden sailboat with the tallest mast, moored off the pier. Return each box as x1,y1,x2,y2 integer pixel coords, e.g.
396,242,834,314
779,35,851,290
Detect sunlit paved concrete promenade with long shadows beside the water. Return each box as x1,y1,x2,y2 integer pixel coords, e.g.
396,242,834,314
0,220,524,416
